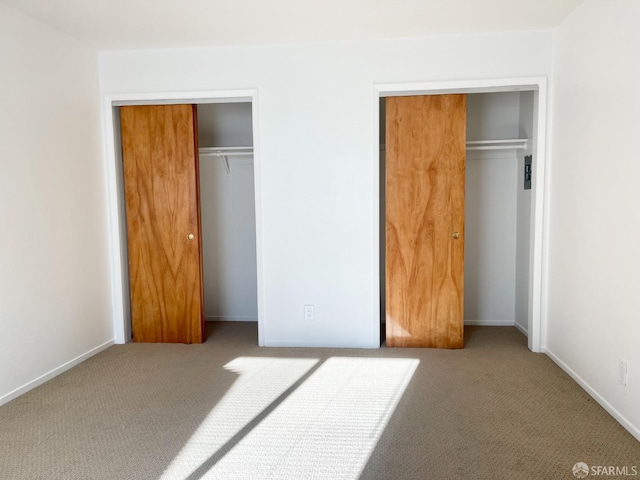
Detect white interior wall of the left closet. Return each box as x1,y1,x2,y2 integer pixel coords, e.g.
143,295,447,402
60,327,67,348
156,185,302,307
198,103,258,321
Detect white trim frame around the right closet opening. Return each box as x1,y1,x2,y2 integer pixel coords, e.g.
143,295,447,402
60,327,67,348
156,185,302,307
371,75,549,352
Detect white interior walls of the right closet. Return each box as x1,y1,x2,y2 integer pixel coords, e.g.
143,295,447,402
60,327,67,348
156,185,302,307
379,92,535,333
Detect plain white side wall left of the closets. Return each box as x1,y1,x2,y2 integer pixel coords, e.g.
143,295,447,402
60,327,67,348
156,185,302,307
0,2,113,403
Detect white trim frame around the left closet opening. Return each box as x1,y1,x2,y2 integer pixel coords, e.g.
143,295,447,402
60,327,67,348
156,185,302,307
101,89,266,346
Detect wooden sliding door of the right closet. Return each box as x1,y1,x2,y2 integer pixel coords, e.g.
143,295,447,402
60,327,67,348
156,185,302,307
385,95,466,348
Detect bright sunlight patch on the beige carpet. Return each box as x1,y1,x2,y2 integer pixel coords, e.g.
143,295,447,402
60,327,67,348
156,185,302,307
162,357,419,480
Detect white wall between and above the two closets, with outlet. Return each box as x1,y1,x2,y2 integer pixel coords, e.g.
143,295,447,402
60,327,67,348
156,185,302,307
100,31,553,346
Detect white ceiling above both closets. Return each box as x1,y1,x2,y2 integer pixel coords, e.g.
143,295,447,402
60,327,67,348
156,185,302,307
4,0,582,49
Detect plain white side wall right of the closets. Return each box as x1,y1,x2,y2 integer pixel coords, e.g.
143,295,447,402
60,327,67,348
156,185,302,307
546,0,640,439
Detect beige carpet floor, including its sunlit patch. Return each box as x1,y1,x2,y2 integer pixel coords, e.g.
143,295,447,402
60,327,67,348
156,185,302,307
0,323,640,480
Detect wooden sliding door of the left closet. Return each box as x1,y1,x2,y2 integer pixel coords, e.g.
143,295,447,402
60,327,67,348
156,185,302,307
120,105,204,343
